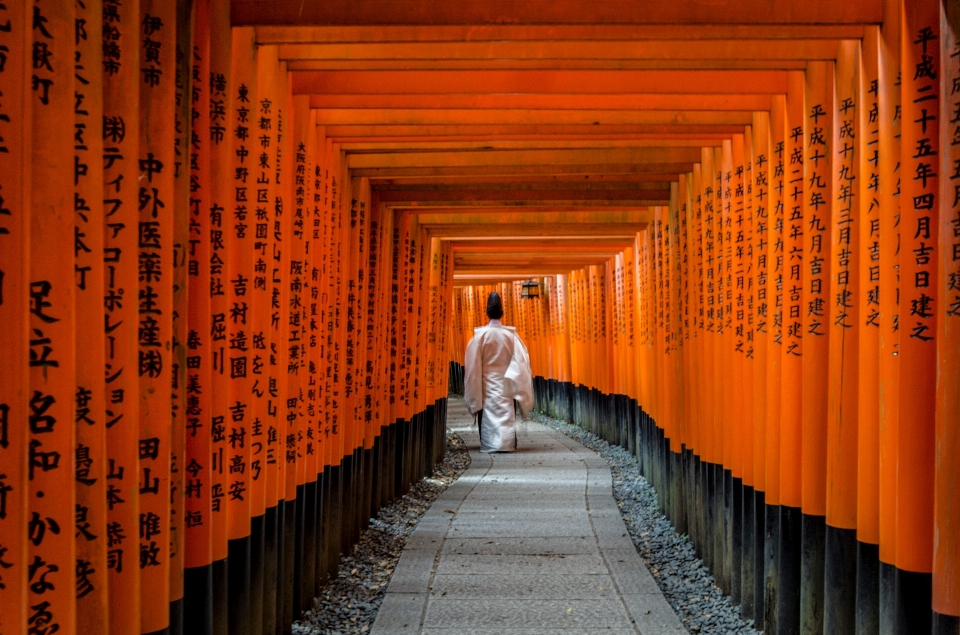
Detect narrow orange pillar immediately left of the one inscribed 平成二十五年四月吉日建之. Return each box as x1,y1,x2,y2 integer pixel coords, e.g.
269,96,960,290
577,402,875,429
877,0,902,633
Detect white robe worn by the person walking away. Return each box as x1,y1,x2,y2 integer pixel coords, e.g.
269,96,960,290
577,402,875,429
463,321,533,452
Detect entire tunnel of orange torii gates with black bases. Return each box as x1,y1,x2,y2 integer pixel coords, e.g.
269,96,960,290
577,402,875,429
0,0,960,635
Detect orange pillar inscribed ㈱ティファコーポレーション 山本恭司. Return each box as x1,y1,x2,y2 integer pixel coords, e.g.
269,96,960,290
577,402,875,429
102,1,140,635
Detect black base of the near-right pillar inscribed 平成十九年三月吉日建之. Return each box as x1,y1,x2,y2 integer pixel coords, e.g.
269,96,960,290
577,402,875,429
823,525,857,633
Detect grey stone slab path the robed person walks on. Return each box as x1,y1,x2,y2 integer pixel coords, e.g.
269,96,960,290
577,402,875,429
371,399,686,635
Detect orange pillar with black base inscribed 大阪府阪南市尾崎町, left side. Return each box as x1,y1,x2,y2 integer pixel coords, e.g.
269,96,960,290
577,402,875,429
287,97,316,614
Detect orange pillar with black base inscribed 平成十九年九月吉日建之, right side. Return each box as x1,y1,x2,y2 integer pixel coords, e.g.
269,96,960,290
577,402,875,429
800,62,835,632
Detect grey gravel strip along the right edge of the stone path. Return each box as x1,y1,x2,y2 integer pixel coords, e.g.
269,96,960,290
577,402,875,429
533,413,757,635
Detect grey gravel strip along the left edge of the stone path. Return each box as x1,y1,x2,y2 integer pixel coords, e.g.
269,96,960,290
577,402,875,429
293,434,470,635
